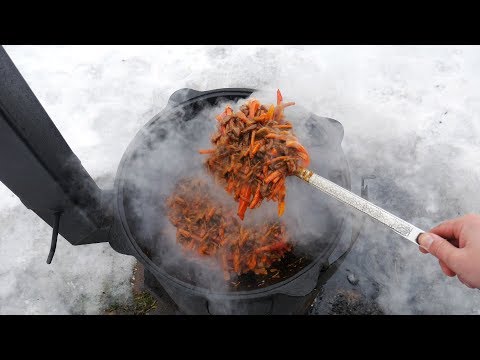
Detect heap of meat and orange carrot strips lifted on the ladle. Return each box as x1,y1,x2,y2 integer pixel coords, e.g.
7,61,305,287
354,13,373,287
199,90,310,220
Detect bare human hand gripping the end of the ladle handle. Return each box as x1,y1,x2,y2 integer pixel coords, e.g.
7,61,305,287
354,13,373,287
418,214,480,288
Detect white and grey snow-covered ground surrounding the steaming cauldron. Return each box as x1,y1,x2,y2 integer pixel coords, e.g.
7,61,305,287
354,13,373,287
0,46,480,314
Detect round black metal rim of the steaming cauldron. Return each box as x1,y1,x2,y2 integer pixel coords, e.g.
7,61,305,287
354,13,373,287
114,88,351,299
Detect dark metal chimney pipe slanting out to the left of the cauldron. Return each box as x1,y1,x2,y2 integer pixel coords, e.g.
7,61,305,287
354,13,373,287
0,46,111,261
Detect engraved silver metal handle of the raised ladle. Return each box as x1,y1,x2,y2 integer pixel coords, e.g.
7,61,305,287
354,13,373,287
296,169,425,245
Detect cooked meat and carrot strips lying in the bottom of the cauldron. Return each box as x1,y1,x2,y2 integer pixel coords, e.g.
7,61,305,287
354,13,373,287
167,179,292,280
